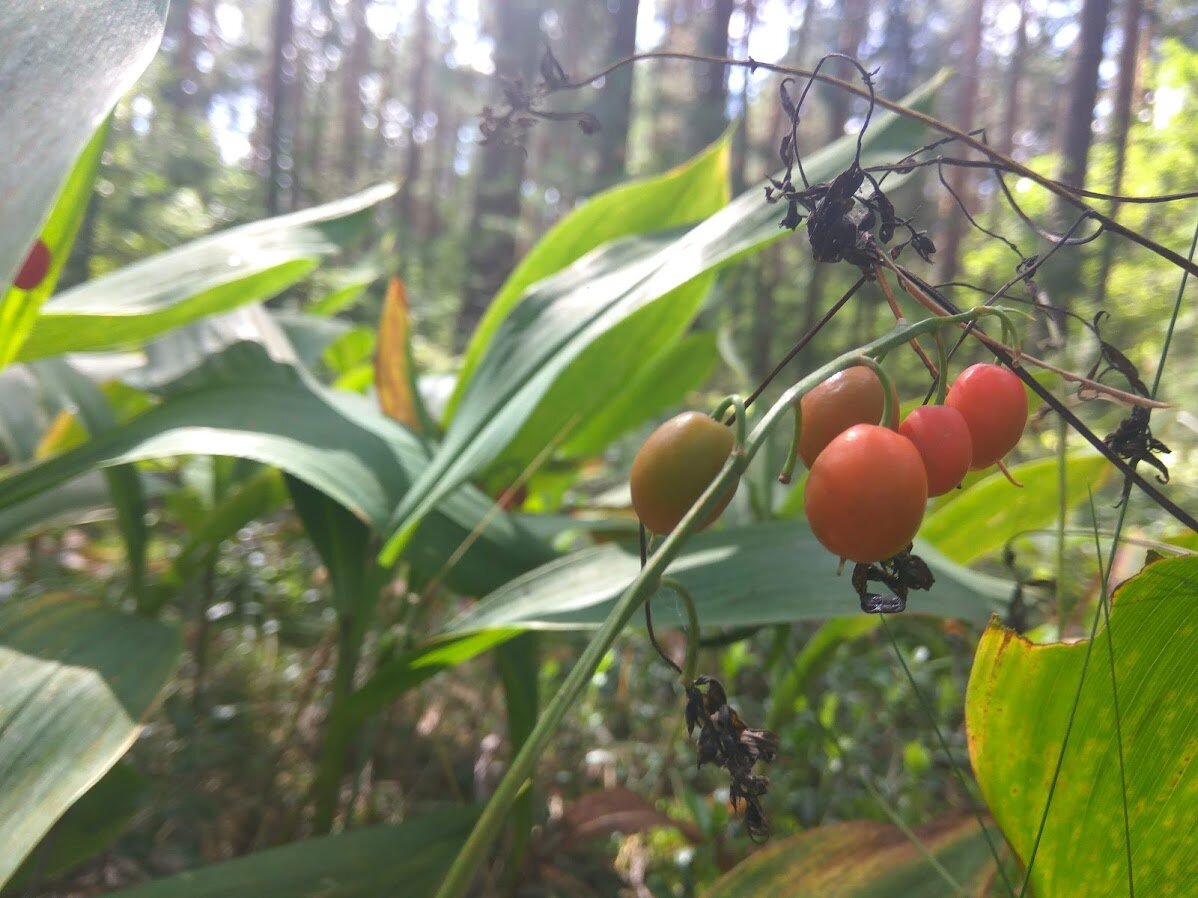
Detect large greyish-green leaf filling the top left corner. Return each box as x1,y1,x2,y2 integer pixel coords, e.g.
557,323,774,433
0,0,167,308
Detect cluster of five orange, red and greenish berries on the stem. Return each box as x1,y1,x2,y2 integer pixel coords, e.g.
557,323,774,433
630,364,1028,564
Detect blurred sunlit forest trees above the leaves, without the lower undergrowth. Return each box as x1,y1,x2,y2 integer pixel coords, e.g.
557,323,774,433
65,0,1198,372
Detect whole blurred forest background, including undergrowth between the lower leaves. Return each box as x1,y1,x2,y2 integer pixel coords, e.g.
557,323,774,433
16,0,1198,896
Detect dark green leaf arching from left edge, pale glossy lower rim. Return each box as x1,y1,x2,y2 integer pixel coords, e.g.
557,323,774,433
0,342,552,594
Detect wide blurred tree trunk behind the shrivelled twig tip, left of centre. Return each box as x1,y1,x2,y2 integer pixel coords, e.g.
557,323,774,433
455,0,541,345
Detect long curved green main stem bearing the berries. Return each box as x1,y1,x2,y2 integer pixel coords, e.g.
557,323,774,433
436,310,978,898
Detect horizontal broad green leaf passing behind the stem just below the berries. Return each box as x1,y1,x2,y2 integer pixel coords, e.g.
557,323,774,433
449,521,1011,633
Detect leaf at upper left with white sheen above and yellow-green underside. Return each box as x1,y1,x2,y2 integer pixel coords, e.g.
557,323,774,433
19,184,394,359
